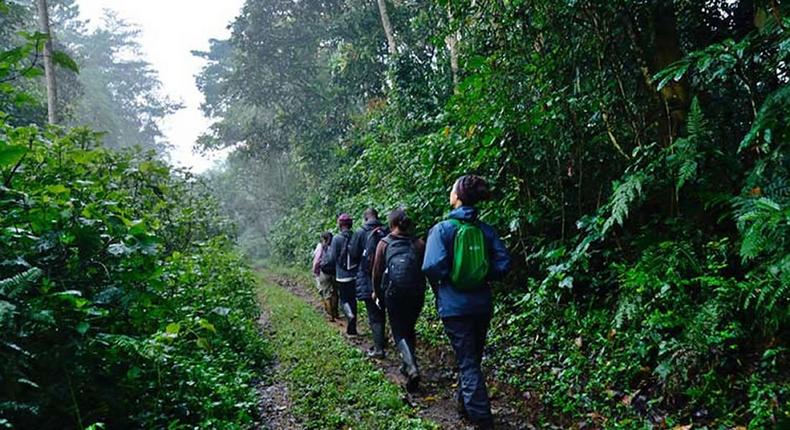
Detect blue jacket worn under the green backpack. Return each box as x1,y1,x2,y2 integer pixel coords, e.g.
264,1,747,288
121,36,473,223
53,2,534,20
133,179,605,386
422,206,511,318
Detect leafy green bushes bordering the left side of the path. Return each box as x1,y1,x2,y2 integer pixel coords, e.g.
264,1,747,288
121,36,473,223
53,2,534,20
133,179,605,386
0,2,269,429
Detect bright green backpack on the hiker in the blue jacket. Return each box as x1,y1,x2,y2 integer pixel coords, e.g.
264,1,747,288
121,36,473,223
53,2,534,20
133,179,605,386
450,219,488,291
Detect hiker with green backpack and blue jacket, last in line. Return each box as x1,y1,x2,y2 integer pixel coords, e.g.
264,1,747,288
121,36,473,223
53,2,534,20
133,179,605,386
422,175,511,429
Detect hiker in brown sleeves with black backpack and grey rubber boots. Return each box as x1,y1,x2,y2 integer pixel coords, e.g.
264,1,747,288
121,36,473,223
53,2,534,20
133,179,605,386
372,209,425,393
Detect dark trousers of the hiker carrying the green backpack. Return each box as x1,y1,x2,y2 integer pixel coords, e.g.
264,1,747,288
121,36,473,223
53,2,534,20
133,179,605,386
442,314,493,425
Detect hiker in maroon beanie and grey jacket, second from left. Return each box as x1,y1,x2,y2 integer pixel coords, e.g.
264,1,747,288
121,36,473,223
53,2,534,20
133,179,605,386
327,214,357,336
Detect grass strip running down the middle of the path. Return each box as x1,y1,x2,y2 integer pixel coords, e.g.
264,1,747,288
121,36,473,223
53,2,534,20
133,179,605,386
259,279,438,430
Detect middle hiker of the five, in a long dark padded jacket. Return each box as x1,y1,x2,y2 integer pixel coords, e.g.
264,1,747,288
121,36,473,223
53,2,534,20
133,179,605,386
351,208,389,358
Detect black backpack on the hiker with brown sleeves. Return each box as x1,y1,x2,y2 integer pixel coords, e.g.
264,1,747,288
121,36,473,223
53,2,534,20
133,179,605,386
382,236,425,298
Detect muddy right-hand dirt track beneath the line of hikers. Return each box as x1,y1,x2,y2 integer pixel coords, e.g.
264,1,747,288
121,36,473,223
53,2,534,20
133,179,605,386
265,274,535,430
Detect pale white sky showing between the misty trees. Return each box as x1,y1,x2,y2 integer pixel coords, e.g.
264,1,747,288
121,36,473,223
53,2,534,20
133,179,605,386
77,0,244,172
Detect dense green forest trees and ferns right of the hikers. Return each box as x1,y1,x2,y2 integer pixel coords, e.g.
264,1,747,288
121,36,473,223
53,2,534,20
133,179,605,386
203,0,790,428
